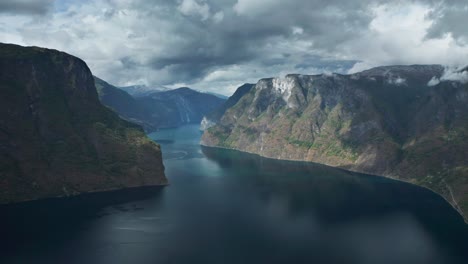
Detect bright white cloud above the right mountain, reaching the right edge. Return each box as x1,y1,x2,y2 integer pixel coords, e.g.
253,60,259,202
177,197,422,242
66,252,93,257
346,3,468,73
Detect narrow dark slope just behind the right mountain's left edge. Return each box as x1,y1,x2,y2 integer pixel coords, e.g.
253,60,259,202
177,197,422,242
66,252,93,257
200,83,255,131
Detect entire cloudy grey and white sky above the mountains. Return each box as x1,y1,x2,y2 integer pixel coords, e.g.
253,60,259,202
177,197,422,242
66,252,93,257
0,0,468,94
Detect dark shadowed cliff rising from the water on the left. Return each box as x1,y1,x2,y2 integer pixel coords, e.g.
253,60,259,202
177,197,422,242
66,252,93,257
0,44,167,203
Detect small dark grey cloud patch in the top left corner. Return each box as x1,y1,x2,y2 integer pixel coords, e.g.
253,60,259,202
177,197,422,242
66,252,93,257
0,0,54,15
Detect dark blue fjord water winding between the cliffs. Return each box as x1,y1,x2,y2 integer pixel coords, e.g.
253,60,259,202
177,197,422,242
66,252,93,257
0,126,468,264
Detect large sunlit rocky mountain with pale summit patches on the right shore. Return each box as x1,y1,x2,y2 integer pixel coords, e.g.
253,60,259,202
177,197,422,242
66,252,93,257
202,65,468,220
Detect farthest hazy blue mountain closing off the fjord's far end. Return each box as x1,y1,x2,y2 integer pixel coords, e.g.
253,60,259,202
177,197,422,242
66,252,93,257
137,87,225,127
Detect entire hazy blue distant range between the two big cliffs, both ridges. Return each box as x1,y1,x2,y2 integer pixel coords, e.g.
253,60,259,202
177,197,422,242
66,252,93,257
95,77,226,131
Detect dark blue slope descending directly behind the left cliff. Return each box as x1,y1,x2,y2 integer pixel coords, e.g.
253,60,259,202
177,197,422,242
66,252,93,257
94,77,157,131
